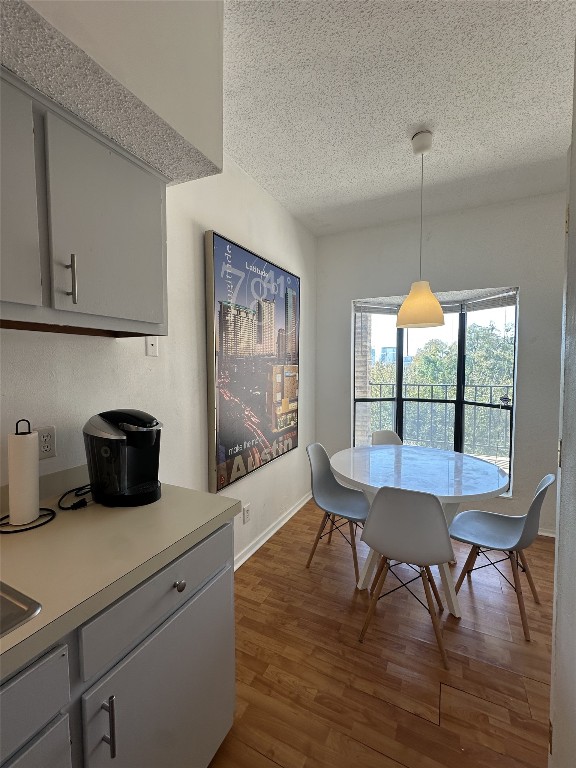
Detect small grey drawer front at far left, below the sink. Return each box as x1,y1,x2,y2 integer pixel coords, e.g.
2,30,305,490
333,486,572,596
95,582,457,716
0,645,70,762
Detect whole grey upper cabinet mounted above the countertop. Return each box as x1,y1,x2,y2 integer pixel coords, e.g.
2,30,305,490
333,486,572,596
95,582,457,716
0,73,168,336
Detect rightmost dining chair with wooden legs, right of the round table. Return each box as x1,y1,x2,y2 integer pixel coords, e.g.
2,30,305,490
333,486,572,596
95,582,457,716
450,474,556,641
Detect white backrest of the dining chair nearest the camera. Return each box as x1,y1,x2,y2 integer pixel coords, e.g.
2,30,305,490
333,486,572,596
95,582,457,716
362,487,454,565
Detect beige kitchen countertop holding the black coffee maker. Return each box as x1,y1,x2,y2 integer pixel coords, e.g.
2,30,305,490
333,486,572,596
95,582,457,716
0,484,241,678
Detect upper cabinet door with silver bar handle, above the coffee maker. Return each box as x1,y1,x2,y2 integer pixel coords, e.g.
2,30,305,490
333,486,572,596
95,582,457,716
46,113,165,323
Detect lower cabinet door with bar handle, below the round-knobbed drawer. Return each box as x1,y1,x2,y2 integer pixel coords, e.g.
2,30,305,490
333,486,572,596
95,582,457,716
82,566,234,768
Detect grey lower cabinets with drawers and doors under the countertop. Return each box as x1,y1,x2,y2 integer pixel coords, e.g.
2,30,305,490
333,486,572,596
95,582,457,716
0,522,235,768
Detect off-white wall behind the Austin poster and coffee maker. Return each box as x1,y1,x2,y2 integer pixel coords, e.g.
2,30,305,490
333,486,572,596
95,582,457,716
0,156,315,554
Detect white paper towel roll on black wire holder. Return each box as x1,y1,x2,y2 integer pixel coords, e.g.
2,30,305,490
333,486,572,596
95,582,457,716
8,419,40,525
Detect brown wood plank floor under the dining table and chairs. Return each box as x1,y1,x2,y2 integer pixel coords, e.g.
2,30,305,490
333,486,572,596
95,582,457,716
211,502,554,768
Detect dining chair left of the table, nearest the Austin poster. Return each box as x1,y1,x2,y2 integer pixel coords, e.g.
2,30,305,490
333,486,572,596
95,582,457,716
306,443,370,583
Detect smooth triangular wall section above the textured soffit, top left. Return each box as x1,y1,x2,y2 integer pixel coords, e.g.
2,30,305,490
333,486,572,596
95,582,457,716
28,0,224,168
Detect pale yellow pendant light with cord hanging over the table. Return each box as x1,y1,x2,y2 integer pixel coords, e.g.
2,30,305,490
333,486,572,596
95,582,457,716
396,131,444,328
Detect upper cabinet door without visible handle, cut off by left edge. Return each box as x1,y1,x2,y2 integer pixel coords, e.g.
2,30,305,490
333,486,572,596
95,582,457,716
0,80,42,305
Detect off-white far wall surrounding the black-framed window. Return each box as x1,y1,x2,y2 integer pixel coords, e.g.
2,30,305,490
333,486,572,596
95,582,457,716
316,193,565,533
